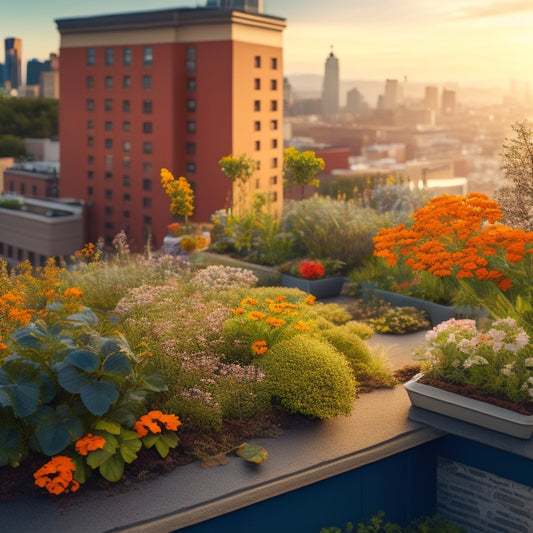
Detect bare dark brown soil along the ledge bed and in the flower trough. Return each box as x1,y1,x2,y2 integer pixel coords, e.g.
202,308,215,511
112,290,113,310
0,365,533,502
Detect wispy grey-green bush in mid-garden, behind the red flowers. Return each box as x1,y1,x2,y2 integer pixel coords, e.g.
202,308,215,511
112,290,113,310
281,196,406,268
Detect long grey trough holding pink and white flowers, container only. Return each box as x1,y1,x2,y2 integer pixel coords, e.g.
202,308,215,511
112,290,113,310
404,374,533,439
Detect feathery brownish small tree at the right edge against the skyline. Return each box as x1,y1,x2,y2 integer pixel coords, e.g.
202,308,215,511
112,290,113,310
495,121,533,231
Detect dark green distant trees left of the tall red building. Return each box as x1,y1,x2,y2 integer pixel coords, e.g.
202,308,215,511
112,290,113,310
0,97,58,139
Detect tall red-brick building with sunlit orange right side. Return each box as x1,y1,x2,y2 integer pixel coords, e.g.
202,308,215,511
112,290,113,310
56,8,285,249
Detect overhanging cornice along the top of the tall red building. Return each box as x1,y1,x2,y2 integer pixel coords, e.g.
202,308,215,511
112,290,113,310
55,8,286,34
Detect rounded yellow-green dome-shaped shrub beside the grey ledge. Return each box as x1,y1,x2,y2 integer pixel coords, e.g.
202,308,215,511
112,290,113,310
258,336,356,419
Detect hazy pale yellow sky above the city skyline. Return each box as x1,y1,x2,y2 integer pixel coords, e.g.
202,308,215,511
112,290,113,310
4,0,533,84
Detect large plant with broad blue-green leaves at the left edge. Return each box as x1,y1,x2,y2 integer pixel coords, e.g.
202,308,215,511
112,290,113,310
0,308,165,466
